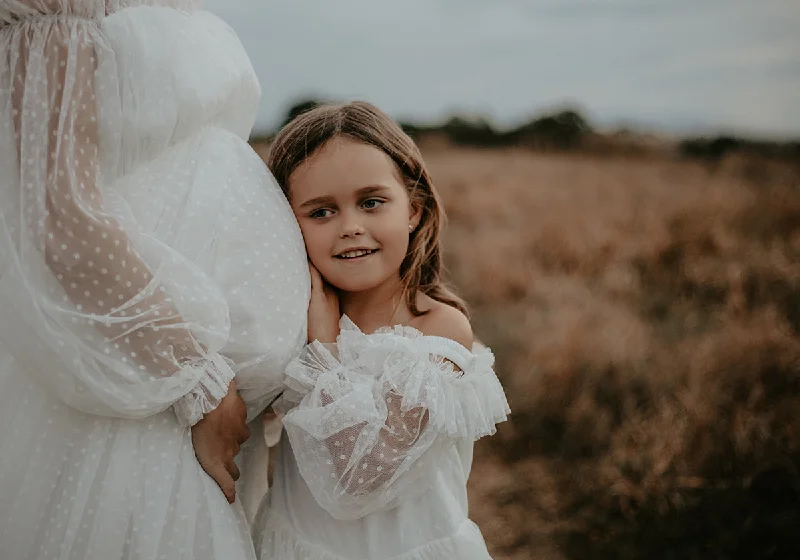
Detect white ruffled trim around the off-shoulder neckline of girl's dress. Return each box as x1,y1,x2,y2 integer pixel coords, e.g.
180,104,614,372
275,316,511,440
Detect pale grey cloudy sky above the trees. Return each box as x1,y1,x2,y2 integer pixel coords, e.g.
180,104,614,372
205,0,800,137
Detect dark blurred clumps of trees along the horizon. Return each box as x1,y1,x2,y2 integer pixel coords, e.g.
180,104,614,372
254,99,800,163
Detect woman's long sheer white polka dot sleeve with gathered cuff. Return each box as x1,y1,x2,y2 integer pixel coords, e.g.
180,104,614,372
0,0,238,424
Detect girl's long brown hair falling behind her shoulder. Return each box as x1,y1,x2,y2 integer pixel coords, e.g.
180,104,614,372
267,101,467,317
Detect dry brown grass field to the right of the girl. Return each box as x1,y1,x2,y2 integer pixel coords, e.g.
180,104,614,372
259,144,800,560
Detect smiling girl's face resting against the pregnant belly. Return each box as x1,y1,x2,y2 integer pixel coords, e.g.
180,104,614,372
289,138,419,292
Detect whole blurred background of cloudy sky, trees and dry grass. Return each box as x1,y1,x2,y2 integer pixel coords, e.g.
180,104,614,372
205,0,800,560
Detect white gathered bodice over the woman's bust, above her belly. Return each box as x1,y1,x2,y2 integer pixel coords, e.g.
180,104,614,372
101,5,261,173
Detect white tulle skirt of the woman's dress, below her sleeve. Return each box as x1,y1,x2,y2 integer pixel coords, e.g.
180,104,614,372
0,347,253,560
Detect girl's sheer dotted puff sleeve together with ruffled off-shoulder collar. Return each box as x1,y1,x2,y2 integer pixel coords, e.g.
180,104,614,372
279,323,509,519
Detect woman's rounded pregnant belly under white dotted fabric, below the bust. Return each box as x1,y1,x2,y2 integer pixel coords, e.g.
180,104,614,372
107,127,310,414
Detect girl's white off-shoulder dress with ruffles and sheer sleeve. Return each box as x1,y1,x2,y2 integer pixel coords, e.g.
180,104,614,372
254,317,510,560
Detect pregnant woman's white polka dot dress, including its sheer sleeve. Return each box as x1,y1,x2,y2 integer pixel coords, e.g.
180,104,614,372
0,0,309,560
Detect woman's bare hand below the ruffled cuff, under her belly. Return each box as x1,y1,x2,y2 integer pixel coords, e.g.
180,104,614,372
192,380,250,504
